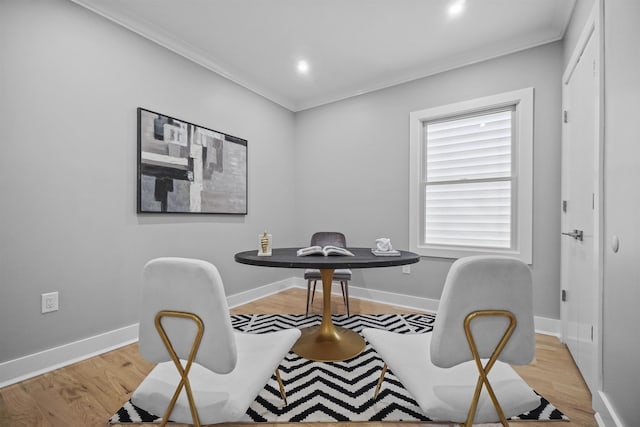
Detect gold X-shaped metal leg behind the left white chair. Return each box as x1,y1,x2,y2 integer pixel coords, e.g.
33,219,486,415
155,310,204,427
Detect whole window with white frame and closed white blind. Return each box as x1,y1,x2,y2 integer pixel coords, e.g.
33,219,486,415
409,88,533,263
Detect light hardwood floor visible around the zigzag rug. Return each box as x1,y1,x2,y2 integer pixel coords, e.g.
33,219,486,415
0,289,597,427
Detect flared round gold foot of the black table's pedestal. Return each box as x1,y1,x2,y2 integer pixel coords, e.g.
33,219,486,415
292,325,365,362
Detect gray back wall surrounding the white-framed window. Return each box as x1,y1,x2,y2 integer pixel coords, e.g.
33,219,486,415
295,42,563,319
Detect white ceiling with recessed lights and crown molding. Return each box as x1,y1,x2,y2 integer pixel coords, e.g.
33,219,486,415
73,0,574,111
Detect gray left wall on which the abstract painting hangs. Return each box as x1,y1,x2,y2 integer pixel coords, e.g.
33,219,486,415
0,0,295,362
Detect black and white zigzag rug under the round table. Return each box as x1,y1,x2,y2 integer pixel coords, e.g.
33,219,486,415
109,314,568,424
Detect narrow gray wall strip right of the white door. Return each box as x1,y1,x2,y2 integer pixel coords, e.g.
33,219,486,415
603,0,640,426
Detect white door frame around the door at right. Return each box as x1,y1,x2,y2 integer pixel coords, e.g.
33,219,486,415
560,0,604,397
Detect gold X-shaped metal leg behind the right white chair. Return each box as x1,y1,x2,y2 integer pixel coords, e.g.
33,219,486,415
464,310,517,427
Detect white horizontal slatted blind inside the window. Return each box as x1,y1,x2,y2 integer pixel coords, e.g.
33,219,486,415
423,108,514,248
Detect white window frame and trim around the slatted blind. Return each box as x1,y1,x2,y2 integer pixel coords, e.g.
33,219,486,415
409,88,534,264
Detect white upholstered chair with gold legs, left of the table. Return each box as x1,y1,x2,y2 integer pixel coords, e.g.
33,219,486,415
131,258,300,426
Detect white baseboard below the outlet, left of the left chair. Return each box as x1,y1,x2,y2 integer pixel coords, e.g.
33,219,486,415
0,324,138,388
